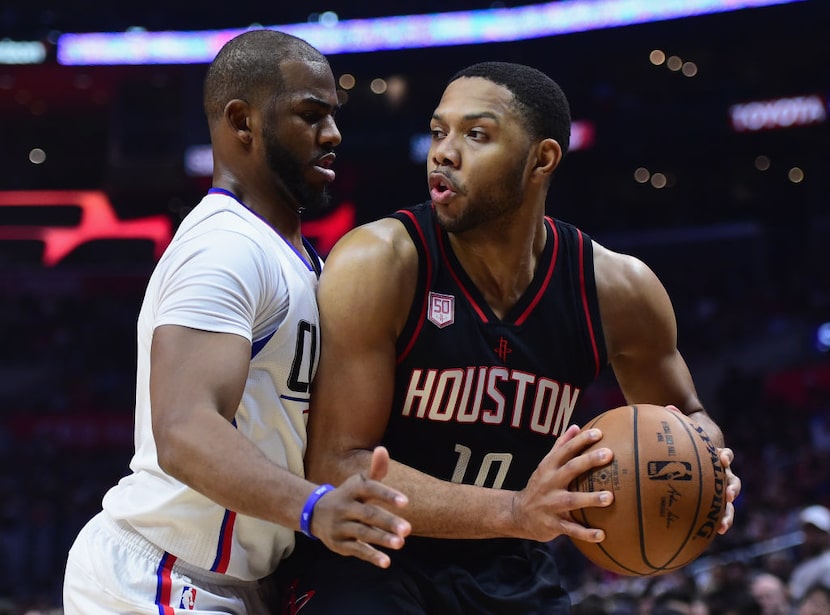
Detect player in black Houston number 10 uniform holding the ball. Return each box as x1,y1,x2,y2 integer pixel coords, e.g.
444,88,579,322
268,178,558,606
272,63,740,615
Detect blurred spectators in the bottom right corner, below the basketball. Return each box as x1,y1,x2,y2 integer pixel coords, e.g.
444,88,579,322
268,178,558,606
560,504,830,615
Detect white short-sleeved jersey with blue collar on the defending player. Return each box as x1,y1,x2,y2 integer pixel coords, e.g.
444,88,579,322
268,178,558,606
103,189,321,580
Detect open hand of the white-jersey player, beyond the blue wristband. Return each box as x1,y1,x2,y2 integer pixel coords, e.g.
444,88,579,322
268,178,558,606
311,446,412,568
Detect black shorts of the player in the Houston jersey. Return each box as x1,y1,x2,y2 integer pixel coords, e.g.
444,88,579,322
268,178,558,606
269,536,571,615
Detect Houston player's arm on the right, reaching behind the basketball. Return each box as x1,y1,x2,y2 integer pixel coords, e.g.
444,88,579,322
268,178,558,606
594,243,741,533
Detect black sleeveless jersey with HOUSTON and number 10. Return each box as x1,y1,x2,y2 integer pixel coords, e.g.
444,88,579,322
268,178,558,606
384,202,607,489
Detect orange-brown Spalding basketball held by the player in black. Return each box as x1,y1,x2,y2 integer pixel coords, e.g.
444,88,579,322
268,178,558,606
571,404,726,576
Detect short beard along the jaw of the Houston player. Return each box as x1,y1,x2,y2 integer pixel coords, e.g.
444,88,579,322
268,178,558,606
438,157,526,233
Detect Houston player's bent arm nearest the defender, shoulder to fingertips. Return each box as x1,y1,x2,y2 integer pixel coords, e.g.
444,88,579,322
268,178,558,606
306,220,610,541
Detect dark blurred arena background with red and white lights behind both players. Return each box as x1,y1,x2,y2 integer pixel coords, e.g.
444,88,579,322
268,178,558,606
0,0,830,615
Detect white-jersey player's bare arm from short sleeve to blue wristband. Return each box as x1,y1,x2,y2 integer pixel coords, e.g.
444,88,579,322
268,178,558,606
150,325,312,527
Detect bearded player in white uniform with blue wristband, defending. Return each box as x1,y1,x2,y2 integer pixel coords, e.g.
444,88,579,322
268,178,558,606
64,30,410,615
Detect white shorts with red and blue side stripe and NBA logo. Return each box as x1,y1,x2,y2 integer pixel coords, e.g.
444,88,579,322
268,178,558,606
63,512,267,615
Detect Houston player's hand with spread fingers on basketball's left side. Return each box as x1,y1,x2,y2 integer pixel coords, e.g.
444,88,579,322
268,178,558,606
513,425,614,542
